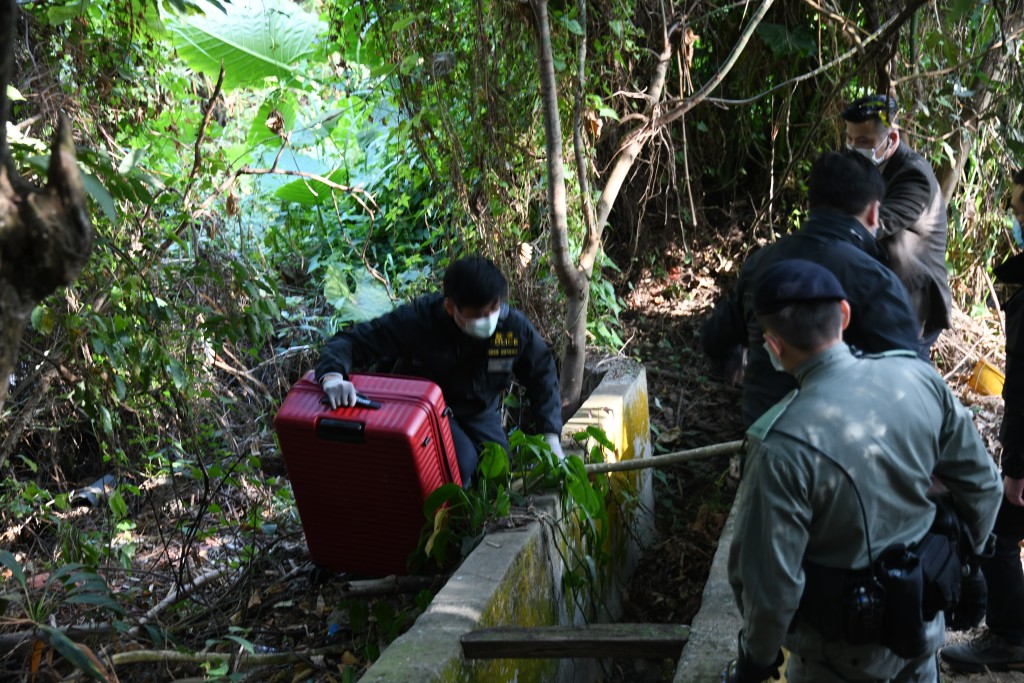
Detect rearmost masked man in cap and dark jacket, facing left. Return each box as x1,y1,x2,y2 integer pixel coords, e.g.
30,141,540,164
843,95,952,359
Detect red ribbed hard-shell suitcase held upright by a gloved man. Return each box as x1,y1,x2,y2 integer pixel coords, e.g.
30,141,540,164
273,373,461,575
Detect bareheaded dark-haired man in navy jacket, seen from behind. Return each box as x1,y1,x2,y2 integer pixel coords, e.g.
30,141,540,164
700,152,919,425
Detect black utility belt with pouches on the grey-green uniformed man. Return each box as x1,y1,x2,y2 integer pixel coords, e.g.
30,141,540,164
797,532,961,658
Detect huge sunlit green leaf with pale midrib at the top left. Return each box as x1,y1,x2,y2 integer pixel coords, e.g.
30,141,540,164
164,0,325,89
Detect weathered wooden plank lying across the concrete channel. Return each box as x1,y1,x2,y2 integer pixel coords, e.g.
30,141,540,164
462,624,690,659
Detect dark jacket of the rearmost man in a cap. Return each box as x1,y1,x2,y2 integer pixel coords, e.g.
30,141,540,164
877,141,952,335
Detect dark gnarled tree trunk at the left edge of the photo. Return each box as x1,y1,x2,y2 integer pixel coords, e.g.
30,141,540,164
0,0,93,410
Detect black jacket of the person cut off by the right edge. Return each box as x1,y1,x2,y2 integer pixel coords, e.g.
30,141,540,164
992,254,1024,479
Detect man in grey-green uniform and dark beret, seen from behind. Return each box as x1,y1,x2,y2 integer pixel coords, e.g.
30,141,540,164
723,259,1000,683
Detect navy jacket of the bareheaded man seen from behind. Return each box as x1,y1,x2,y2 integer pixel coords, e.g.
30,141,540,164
700,209,918,425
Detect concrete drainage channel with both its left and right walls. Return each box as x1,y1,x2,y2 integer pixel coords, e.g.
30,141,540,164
360,358,739,683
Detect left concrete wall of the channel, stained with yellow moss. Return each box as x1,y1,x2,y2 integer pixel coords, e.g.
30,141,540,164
360,358,654,683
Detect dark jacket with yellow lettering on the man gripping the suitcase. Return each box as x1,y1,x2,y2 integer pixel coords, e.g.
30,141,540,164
316,294,562,434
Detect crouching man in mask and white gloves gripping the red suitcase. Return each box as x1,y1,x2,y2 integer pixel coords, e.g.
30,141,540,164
316,256,564,487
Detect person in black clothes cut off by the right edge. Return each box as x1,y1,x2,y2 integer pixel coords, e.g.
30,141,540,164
941,170,1024,672
